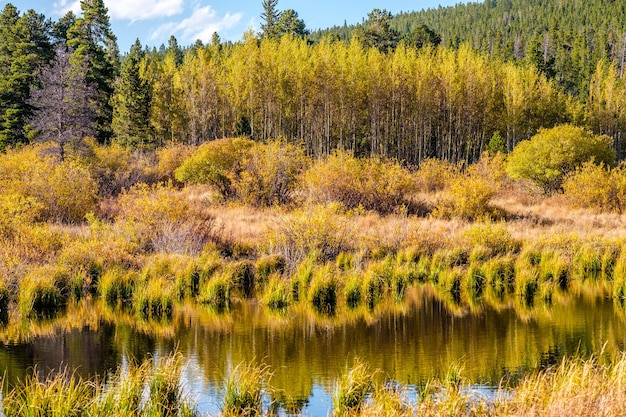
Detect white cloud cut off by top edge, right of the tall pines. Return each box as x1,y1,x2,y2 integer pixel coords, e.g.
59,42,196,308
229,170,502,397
106,0,184,21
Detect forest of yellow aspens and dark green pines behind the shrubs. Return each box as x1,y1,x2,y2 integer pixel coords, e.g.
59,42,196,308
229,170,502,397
0,1,626,165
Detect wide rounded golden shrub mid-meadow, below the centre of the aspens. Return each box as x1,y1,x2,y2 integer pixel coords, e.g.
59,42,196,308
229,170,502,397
304,151,415,213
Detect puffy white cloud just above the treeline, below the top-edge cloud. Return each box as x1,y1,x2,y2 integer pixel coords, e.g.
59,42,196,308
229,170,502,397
151,6,243,42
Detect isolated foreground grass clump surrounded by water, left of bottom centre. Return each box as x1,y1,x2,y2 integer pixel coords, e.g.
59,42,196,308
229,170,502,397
222,363,271,417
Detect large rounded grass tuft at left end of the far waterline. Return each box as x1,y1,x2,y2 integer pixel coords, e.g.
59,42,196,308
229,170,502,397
19,266,70,317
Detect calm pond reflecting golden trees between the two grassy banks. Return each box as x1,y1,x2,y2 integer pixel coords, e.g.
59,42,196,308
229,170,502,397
0,289,626,416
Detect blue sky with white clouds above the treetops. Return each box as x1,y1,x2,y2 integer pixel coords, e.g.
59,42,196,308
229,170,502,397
0,0,458,52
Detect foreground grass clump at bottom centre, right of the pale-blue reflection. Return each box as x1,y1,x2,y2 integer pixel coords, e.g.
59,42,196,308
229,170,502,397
333,359,374,416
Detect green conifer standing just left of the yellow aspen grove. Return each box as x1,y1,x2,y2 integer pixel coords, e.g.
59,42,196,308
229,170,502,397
112,39,153,148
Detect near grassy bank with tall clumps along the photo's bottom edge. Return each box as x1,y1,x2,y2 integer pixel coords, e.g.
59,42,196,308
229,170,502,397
2,354,626,417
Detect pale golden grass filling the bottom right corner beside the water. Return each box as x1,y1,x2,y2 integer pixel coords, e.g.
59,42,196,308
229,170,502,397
355,355,626,417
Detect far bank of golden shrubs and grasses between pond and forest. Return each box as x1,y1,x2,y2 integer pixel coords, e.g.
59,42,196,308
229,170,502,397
0,139,626,321
